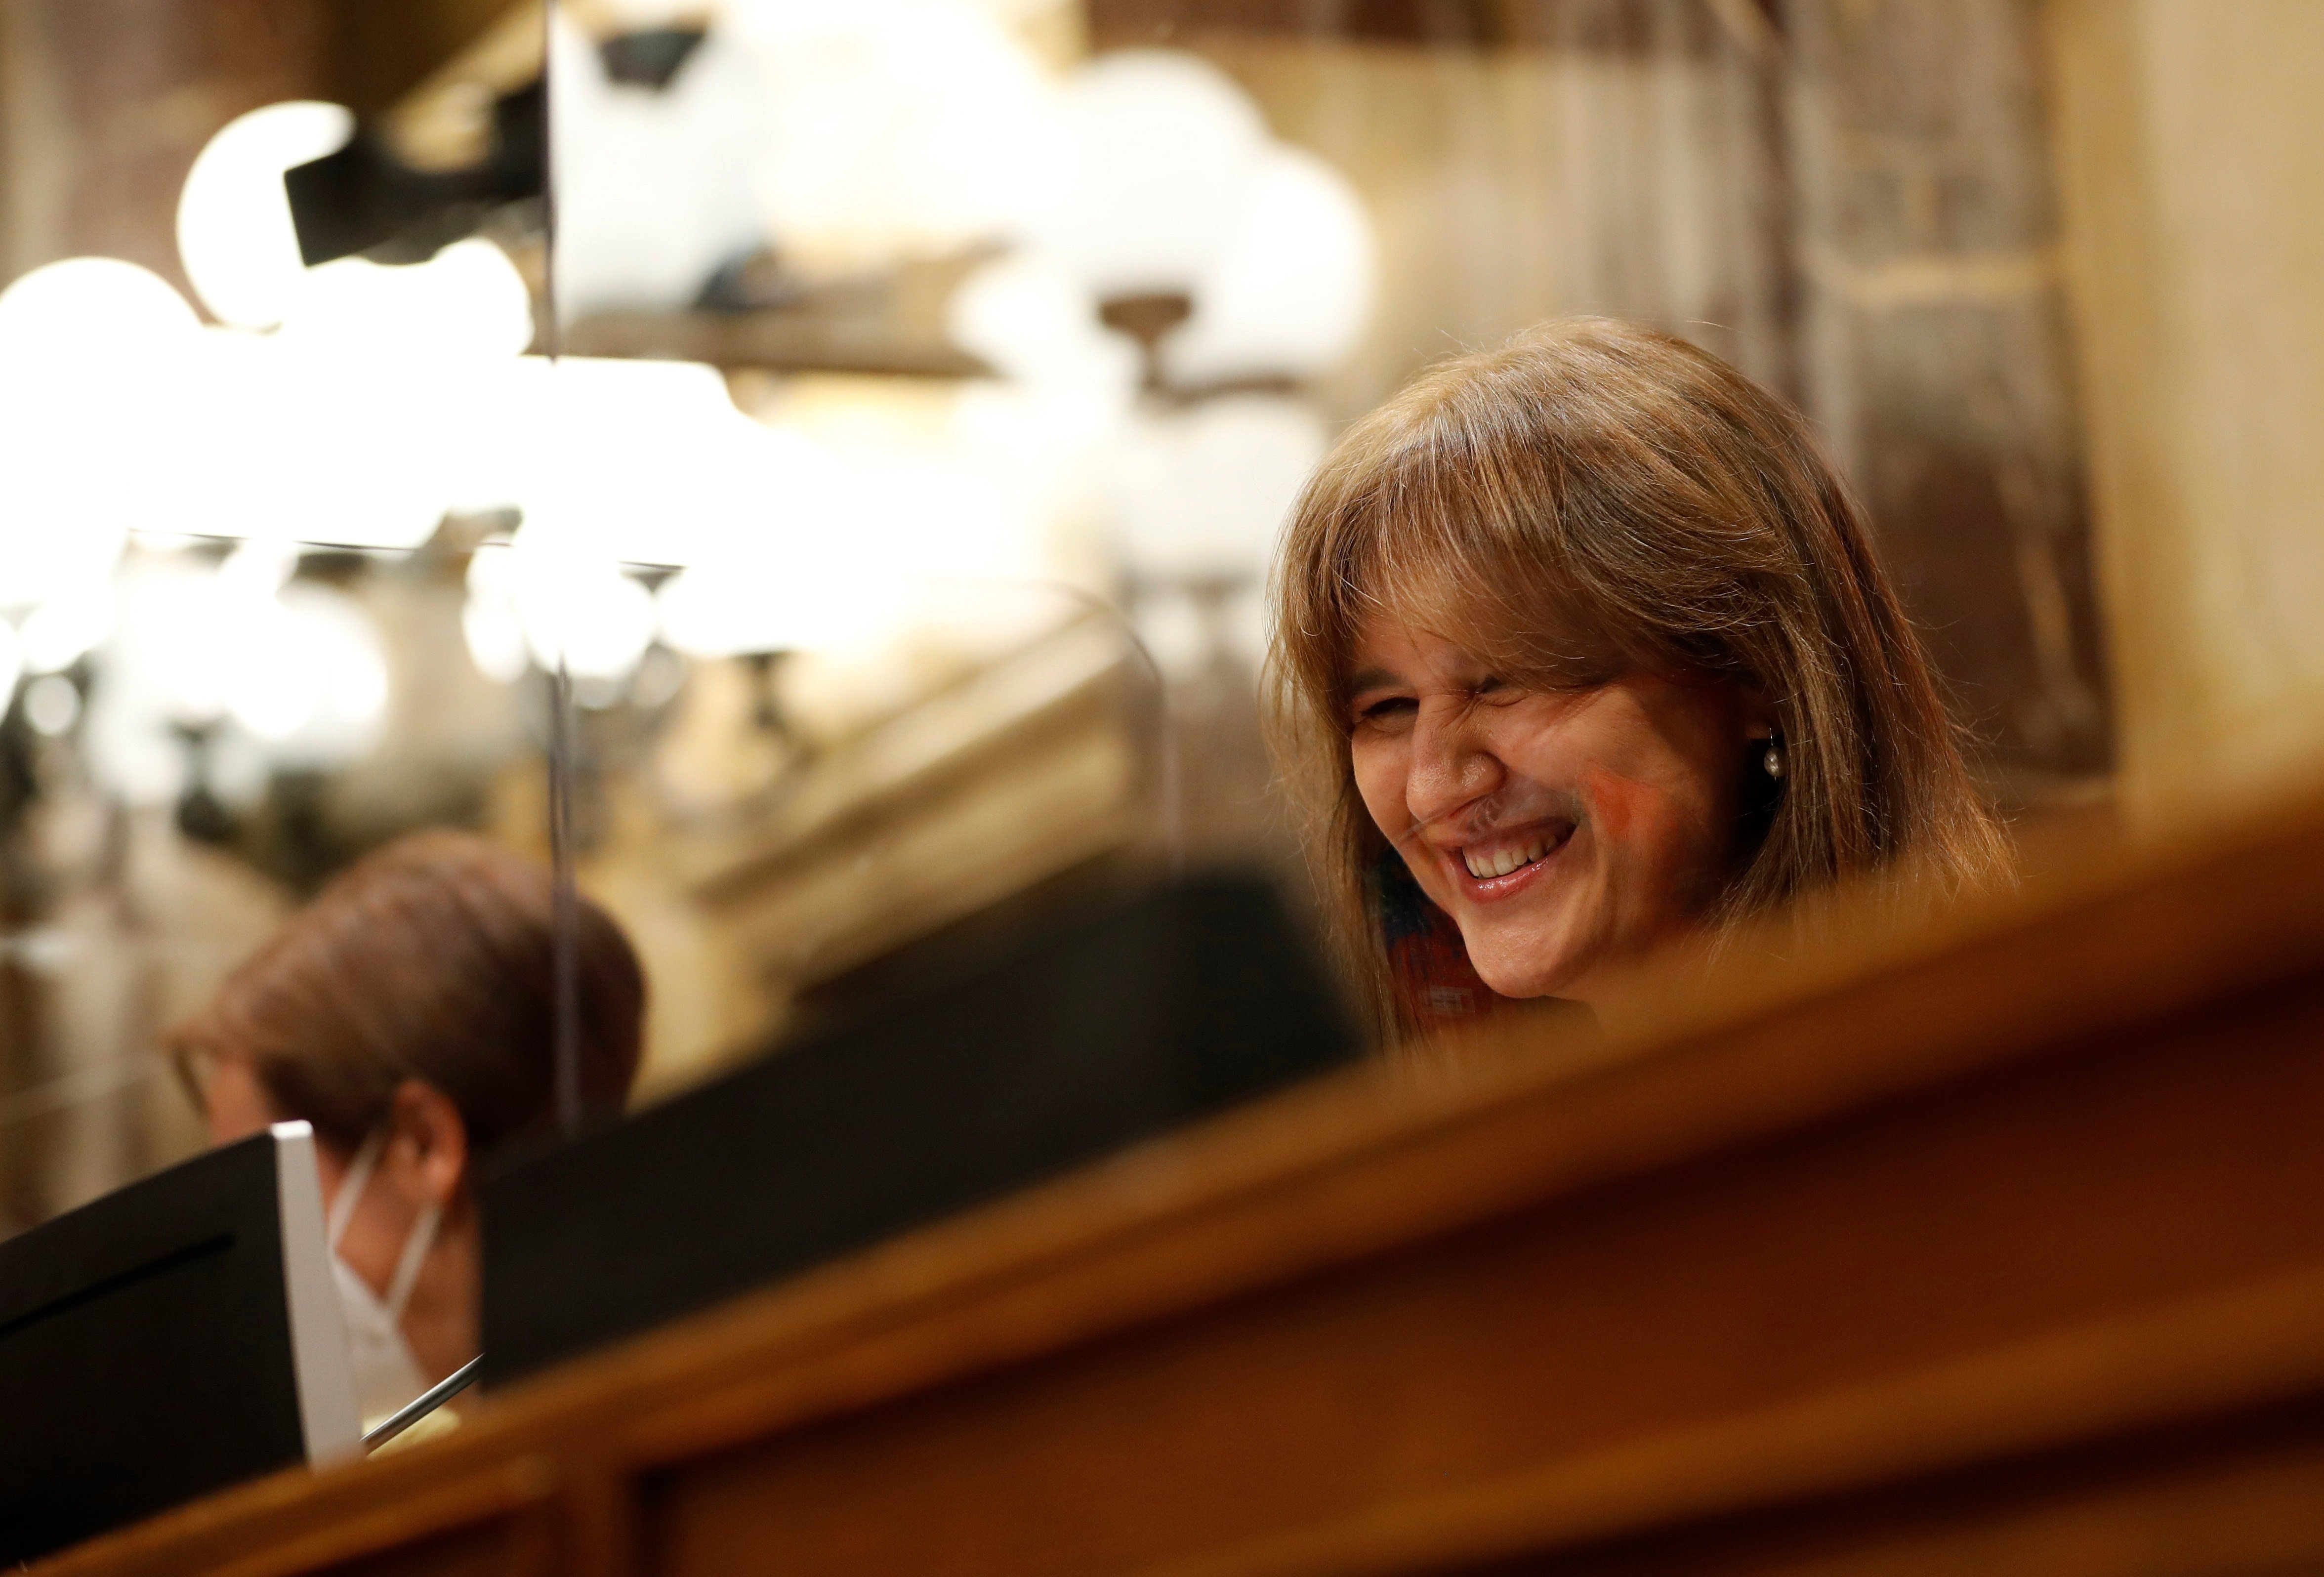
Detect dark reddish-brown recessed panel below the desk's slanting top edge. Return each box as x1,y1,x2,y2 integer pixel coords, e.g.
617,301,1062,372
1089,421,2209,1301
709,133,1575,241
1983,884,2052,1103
648,987,2324,1575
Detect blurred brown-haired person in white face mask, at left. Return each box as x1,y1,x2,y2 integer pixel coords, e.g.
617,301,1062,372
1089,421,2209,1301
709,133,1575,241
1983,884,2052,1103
169,831,646,1428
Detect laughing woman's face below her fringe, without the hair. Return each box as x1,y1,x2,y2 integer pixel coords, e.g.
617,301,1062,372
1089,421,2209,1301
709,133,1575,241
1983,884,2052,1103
1348,616,1771,1001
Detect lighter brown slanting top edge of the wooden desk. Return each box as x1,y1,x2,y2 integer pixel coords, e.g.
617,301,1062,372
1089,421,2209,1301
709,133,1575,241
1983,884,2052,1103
37,806,2324,1577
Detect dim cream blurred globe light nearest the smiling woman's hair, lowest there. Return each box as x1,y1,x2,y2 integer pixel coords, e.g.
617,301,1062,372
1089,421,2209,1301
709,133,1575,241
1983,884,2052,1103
1116,395,1327,581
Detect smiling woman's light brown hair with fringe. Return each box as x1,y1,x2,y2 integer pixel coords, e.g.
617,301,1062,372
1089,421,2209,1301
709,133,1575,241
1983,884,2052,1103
1271,318,2006,1031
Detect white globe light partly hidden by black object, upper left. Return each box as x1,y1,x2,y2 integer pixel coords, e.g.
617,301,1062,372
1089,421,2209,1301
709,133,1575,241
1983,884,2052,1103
177,100,356,330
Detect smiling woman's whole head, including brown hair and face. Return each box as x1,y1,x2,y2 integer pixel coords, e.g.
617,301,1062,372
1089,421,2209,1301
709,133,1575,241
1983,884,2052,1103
1274,321,2003,1027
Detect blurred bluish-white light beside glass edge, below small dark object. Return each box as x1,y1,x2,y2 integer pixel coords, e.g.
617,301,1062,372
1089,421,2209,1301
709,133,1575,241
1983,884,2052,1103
548,12,767,318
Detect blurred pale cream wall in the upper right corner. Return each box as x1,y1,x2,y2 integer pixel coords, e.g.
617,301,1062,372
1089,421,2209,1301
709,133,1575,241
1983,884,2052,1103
2043,0,2324,825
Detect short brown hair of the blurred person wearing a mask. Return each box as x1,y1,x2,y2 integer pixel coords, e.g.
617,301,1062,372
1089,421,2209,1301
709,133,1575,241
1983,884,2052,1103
169,831,646,1157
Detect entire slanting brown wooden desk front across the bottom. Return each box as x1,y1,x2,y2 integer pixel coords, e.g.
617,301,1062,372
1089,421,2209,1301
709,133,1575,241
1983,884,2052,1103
44,808,2324,1577
